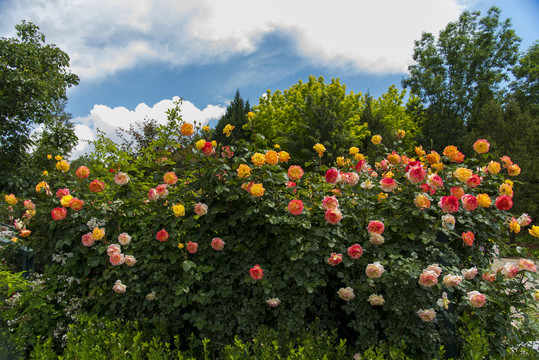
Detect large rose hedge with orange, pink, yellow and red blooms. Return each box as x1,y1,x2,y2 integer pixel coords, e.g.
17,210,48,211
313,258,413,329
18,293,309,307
1,115,539,358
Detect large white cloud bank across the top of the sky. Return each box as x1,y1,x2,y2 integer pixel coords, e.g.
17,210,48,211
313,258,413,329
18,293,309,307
0,0,465,80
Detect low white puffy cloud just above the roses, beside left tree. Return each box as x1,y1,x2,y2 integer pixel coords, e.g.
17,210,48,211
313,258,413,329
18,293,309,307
71,97,226,158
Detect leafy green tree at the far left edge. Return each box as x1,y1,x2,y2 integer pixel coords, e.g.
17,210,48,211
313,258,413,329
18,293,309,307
0,21,79,190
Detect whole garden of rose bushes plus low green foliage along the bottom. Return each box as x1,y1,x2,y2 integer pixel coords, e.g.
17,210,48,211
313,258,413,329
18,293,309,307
0,108,539,359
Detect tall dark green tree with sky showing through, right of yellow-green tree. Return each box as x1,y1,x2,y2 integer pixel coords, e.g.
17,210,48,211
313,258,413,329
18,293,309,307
402,7,520,148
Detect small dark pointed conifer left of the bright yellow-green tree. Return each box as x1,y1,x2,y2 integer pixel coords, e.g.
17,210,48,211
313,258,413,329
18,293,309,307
213,90,252,145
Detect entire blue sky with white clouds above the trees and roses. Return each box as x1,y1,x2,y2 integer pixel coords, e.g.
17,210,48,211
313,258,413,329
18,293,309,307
0,0,539,158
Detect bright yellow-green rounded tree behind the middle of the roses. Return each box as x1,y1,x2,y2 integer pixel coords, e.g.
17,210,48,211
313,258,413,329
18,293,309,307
252,76,369,163
